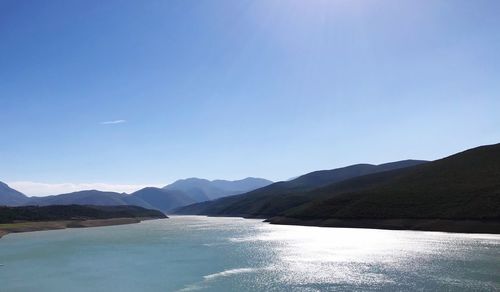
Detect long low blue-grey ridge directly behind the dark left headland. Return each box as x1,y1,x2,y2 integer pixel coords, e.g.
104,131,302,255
24,190,154,209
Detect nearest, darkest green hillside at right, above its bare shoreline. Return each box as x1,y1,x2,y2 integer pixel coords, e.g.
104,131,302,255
280,144,500,222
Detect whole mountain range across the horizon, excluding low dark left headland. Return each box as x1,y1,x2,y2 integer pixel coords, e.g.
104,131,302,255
0,144,500,233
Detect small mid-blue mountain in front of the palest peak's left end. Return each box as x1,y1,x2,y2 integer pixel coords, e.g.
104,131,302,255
130,187,196,212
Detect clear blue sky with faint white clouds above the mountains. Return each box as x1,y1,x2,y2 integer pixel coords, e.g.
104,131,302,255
0,0,500,195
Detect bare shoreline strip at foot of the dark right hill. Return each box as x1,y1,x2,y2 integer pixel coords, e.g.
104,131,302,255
264,217,500,234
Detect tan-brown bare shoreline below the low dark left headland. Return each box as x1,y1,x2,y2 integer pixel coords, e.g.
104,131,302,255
0,217,159,238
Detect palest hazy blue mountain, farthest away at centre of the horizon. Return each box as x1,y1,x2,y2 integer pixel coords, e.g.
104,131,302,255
163,177,272,202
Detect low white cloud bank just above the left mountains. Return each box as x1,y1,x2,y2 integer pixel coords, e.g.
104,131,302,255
7,181,161,196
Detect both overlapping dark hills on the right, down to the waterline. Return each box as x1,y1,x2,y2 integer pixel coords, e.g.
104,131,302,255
174,144,500,233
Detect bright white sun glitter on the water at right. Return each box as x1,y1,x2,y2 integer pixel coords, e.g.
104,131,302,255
226,225,496,289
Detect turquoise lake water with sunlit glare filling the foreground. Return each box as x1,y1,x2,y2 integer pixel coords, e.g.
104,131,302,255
0,216,500,292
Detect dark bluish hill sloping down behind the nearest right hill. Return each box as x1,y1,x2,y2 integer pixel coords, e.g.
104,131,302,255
174,160,426,217
